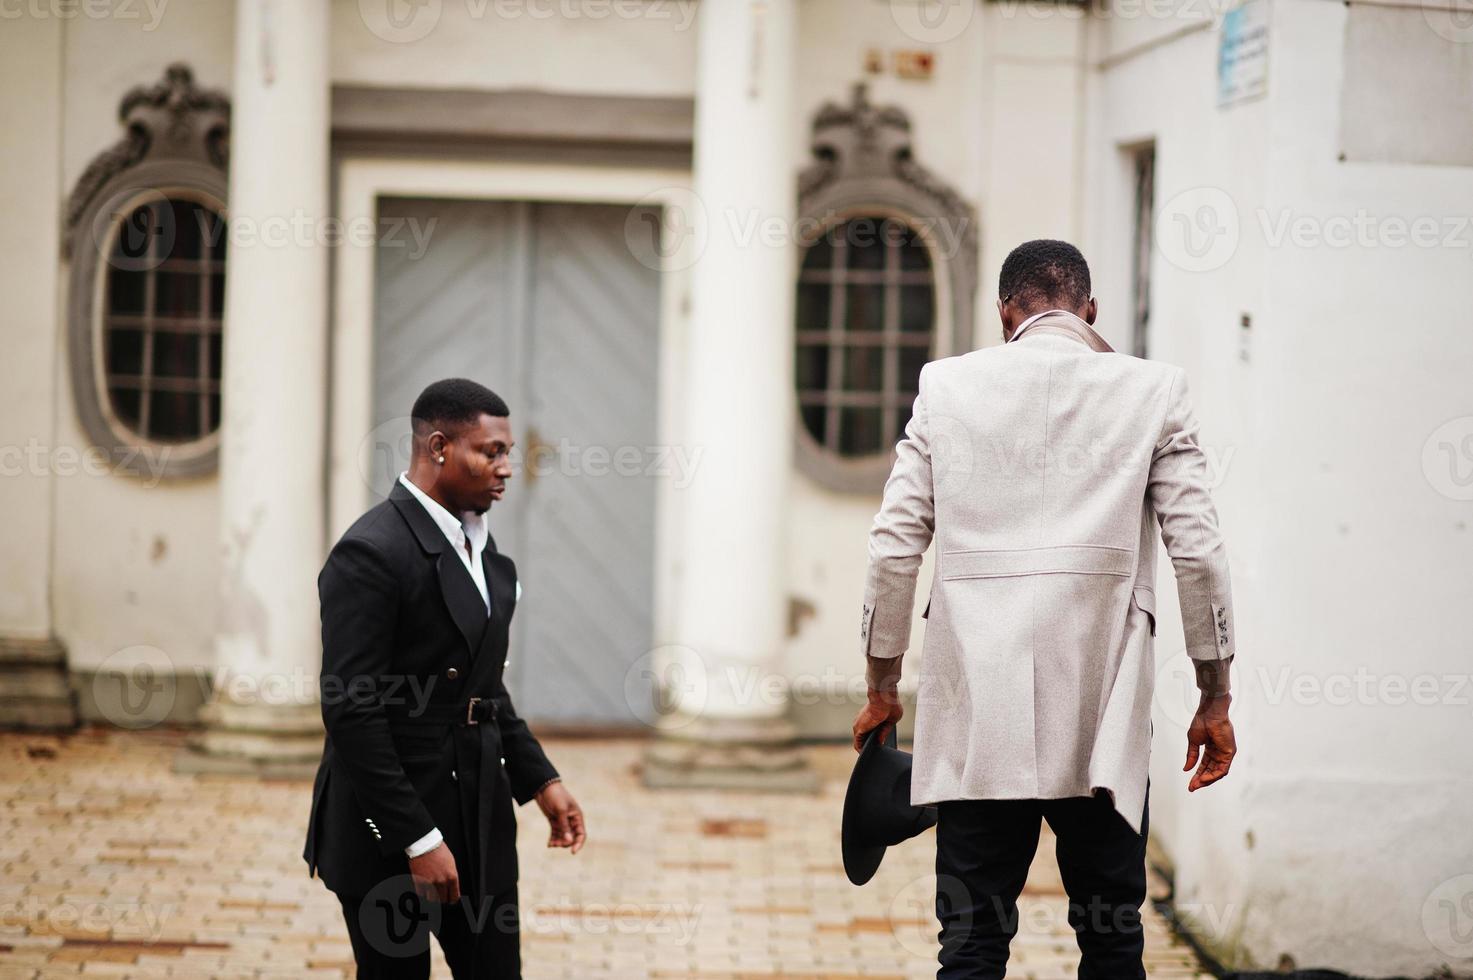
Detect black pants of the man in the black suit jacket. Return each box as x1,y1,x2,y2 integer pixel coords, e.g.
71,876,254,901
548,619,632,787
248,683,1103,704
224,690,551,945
337,875,521,980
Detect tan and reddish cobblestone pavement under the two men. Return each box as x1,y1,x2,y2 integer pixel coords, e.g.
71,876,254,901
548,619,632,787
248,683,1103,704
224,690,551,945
0,729,1208,980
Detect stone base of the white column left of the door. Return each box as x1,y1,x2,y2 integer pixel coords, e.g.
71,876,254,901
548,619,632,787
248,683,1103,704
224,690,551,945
174,700,323,778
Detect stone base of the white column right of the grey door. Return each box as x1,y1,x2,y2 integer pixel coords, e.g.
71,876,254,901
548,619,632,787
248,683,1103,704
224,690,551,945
642,718,822,793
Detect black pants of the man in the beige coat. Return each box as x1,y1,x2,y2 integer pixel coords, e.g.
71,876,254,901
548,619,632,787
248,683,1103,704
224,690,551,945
935,790,1149,980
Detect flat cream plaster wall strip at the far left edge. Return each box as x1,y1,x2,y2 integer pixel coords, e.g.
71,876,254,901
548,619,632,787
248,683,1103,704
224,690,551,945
0,18,66,638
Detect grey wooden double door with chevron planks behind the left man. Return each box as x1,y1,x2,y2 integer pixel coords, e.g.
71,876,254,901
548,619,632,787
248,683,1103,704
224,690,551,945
370,199,660,725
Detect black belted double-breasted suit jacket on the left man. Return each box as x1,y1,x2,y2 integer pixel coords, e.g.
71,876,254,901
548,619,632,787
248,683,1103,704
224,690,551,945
302,483,557,895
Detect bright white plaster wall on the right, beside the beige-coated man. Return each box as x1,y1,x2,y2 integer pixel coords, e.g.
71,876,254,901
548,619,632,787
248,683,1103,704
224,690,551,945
1087,0,1473,976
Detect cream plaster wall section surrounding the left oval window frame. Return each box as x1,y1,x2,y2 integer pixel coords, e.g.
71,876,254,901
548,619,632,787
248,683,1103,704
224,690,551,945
49,0,235,669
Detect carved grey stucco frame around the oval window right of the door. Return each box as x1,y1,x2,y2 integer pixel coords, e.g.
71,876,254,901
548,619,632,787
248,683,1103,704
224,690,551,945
792,83,978,494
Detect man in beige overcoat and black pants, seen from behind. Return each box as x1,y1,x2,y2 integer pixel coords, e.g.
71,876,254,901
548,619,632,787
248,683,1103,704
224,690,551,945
854,240,1236,980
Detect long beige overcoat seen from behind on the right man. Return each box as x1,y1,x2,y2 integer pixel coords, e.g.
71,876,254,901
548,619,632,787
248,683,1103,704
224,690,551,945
860,312,1233,831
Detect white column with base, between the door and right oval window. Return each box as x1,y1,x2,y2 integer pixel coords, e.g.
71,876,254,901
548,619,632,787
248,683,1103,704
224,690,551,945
645,0,812,785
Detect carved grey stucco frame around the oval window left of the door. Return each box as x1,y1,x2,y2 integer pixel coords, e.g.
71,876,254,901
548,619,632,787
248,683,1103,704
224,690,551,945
62,63,230,477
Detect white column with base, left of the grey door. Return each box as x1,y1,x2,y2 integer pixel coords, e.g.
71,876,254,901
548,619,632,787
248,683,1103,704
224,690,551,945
190,0,330,762
